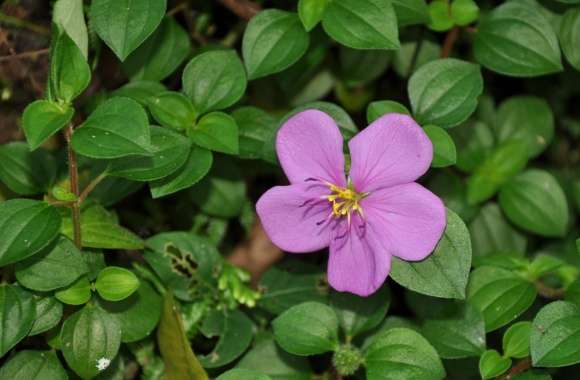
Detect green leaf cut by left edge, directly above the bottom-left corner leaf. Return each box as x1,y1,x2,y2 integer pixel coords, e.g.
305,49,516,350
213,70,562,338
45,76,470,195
0,284,36,358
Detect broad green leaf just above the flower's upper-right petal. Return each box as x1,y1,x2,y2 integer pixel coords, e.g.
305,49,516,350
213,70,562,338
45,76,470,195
408,58,483,128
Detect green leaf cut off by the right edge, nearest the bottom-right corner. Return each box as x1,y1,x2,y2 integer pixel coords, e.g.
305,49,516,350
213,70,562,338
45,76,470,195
530,301,580,367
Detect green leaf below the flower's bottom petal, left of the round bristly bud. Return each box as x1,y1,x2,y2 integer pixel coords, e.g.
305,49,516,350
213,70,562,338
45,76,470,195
272,302,338,356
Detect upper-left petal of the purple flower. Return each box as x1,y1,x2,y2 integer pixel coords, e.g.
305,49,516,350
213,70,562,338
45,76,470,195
276,109,346,187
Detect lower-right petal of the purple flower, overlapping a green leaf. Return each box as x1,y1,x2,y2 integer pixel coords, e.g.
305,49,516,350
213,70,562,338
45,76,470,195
361,183,446,261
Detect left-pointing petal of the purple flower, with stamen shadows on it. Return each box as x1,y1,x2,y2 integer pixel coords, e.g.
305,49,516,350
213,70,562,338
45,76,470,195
256,184,331,253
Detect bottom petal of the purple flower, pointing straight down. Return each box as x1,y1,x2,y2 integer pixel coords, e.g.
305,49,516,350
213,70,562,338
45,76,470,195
328,215,391,297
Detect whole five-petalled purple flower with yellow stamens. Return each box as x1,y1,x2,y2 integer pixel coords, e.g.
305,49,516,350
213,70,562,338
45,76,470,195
256,110,446,296
